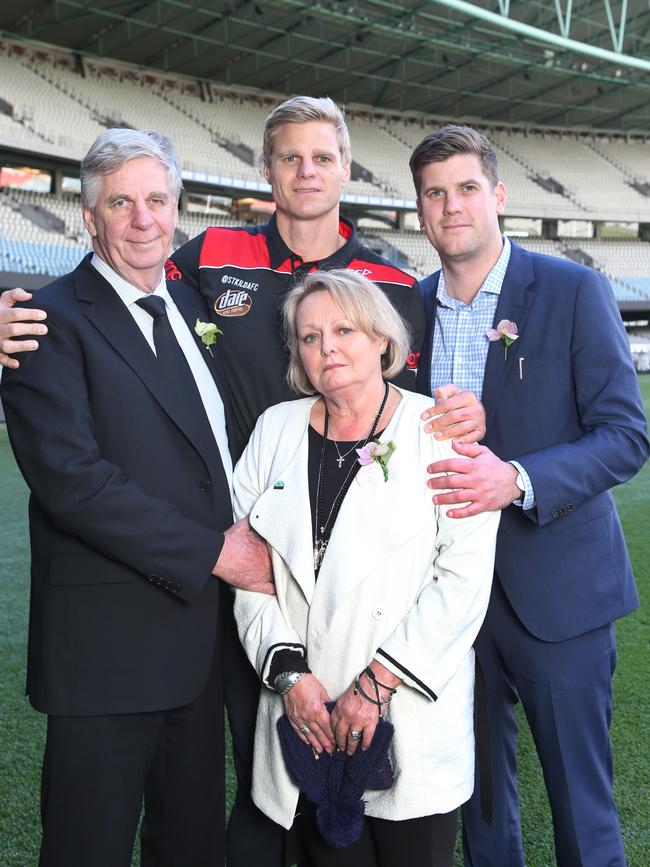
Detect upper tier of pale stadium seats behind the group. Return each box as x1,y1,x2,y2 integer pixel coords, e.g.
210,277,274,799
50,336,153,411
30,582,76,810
0,43,650,222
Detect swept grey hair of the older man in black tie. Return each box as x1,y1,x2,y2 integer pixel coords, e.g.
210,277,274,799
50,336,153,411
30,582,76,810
80,128,183,208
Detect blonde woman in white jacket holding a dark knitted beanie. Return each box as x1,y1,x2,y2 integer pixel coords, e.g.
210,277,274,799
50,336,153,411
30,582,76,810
235,270,499,867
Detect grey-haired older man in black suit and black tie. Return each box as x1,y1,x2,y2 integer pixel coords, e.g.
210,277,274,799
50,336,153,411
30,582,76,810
2,130,272,867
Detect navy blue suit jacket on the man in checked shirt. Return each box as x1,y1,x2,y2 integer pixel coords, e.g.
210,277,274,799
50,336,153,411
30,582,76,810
418,244,649,641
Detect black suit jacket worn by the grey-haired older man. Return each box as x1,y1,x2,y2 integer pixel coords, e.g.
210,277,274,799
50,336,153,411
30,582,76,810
2,257,232,715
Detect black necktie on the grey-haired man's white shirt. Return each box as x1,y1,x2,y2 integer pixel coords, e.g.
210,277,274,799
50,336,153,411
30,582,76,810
135,295,212,430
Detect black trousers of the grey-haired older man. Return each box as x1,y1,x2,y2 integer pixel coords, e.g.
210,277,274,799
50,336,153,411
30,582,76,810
39,641,225,867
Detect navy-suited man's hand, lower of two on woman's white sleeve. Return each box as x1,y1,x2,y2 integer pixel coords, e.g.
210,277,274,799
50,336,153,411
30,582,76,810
427,440,522,518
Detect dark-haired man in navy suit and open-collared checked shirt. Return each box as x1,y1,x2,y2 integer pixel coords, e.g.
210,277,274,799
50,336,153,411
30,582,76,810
411,126,649,867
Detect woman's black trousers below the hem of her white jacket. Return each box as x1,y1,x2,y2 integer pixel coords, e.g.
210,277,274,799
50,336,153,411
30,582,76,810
289,797,458,867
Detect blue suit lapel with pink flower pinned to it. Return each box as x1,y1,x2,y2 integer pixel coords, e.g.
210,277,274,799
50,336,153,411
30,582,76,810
483,242,535,430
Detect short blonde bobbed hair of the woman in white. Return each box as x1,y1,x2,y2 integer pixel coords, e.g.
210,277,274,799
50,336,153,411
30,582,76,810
282,268,411,394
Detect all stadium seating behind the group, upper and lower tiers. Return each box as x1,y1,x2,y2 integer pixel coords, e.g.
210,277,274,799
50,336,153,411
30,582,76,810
0,40,650,302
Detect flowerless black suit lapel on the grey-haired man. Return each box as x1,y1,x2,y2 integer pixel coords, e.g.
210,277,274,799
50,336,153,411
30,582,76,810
75,256,218,467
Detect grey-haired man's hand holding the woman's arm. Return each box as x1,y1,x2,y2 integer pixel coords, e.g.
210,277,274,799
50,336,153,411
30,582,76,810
212,518,275,596
